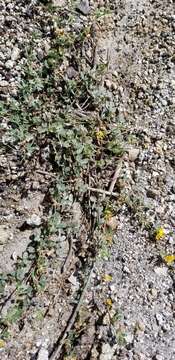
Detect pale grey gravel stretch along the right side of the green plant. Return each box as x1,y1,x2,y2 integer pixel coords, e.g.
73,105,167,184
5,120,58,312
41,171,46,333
89,1,175,360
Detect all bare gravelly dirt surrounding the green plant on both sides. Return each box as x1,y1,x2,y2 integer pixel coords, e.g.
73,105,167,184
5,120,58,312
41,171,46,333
0,0,175,360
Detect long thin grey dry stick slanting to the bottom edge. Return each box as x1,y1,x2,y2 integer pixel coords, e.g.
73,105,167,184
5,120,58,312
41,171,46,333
49,264,94,360
